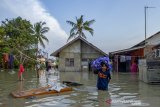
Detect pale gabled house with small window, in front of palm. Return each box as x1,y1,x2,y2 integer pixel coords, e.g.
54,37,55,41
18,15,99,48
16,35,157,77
51,36,106,71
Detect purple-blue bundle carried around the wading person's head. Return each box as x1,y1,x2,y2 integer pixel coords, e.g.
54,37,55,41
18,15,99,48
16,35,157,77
91,56,111,70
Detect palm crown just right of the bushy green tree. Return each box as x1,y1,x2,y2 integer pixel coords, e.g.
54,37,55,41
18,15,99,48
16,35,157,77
33,22,49,49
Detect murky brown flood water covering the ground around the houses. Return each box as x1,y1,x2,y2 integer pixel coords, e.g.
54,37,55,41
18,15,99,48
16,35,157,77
0,70,160,107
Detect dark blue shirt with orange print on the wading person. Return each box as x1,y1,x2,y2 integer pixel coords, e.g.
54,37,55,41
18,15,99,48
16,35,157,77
97,70,111,90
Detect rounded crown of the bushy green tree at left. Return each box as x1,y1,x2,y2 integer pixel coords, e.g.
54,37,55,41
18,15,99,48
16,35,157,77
2,17,35,49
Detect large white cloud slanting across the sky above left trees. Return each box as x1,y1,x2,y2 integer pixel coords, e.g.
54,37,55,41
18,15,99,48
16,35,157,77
1,0,67,54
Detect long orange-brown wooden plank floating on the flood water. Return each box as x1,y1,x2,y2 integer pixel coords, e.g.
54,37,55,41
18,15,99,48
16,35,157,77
11,86,72,98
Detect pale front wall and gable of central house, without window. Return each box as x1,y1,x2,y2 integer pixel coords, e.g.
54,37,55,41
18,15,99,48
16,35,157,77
59,40,103,71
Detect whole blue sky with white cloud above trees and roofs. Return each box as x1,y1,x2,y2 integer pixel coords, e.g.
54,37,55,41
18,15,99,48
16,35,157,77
0,0,160,57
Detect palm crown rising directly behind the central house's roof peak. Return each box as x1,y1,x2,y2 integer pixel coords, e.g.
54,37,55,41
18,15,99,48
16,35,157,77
66,15,95,41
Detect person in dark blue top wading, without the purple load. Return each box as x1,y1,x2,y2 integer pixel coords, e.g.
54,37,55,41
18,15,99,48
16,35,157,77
97,62,111,90
